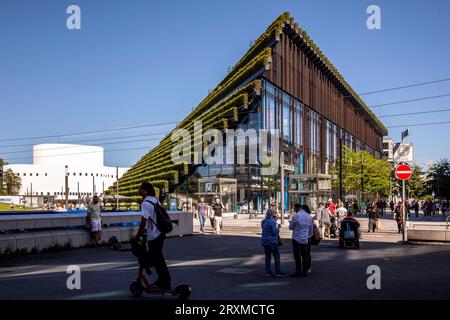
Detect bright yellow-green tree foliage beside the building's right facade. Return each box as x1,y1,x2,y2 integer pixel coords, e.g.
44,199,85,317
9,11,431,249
332,146,391,196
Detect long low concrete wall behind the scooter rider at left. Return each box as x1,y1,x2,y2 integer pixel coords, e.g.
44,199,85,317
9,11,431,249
0,211,193,252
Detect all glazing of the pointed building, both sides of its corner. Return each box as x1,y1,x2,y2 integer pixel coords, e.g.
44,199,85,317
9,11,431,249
172,79,382,212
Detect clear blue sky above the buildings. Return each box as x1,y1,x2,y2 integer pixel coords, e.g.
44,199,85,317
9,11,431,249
0,0,450,166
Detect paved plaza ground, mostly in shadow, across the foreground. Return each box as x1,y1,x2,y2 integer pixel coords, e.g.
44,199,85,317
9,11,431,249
0,216,450,299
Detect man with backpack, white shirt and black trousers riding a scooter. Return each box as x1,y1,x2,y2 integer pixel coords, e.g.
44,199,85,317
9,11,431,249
136,182,171,290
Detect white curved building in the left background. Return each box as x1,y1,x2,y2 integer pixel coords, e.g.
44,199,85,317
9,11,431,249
4,143,129,200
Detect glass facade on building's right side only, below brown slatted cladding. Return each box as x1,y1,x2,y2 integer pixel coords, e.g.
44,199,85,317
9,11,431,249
261,80,376,209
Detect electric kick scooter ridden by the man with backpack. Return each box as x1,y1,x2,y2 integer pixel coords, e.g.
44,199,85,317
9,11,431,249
130,236,192,300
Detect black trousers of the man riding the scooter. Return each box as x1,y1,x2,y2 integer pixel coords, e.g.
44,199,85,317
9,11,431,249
148,233,171,289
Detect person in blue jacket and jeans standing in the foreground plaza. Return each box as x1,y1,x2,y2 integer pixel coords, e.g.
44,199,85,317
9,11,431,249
261,209,286,277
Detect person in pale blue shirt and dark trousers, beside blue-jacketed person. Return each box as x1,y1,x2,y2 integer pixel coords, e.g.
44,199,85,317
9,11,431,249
289,203,313,277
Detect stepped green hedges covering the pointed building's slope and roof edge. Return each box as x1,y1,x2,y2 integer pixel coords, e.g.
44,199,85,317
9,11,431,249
107,12,387,201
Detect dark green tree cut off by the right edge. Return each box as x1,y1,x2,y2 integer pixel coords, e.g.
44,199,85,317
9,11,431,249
428,159,450,200
